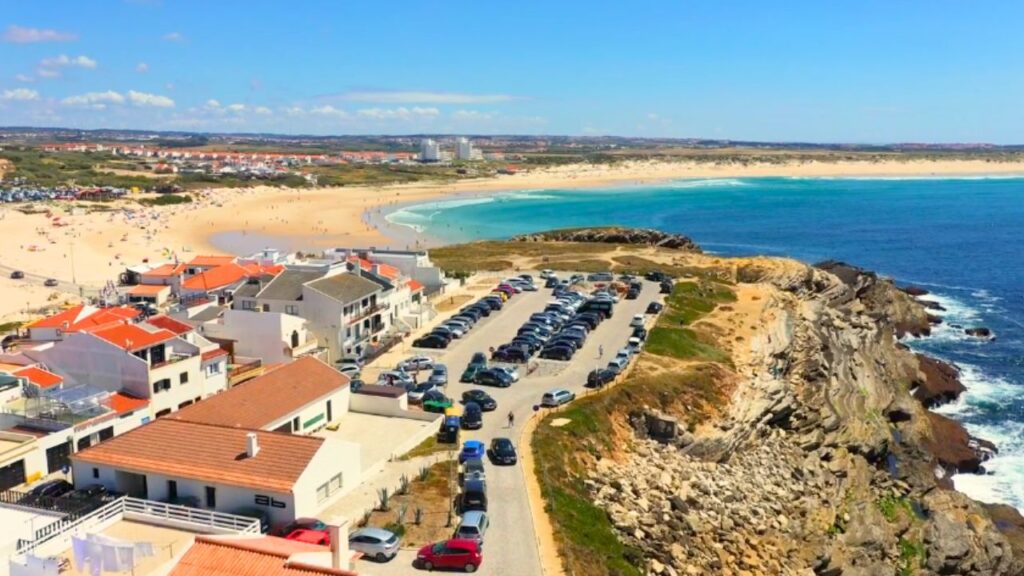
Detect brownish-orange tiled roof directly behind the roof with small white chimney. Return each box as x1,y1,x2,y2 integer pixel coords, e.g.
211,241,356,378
174,356,349,428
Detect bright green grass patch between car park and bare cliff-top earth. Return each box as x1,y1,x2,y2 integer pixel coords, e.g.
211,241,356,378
646,281,736,364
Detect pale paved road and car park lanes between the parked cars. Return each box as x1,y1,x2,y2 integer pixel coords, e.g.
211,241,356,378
356,282,662,576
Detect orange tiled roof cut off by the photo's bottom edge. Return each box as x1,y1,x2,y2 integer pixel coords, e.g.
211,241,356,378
168,536,358,576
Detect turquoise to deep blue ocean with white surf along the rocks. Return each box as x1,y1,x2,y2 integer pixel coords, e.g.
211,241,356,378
386,177,1024,510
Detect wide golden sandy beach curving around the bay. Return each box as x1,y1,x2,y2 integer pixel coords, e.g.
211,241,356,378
0,154,1024,320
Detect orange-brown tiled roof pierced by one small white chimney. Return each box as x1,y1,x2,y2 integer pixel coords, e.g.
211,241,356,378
72,414,324,493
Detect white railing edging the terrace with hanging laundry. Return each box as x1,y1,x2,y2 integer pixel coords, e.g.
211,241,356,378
15,496,260,554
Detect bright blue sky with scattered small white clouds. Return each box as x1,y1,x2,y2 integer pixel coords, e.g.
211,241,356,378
0,0,1024,143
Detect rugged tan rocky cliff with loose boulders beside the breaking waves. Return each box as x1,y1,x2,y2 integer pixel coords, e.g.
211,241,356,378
586,258,1024,576
